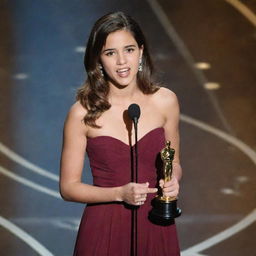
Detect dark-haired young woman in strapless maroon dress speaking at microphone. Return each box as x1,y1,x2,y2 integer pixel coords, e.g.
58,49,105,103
60,12,182,256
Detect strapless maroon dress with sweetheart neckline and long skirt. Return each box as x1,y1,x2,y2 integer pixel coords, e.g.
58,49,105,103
74,128,180,256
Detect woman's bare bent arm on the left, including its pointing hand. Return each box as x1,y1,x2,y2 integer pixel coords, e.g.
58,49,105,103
60,102,156,205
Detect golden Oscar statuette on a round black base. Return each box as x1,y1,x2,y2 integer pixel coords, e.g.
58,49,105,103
149,141,181,226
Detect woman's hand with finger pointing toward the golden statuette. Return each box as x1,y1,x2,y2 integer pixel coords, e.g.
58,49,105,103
119,182,157,205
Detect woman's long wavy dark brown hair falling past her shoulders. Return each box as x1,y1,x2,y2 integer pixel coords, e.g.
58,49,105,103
76,12,159,128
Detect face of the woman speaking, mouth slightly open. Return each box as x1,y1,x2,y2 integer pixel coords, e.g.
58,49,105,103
100,30,143,87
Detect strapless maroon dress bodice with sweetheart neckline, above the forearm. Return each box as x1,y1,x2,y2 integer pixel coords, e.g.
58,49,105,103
87,127,165,187
